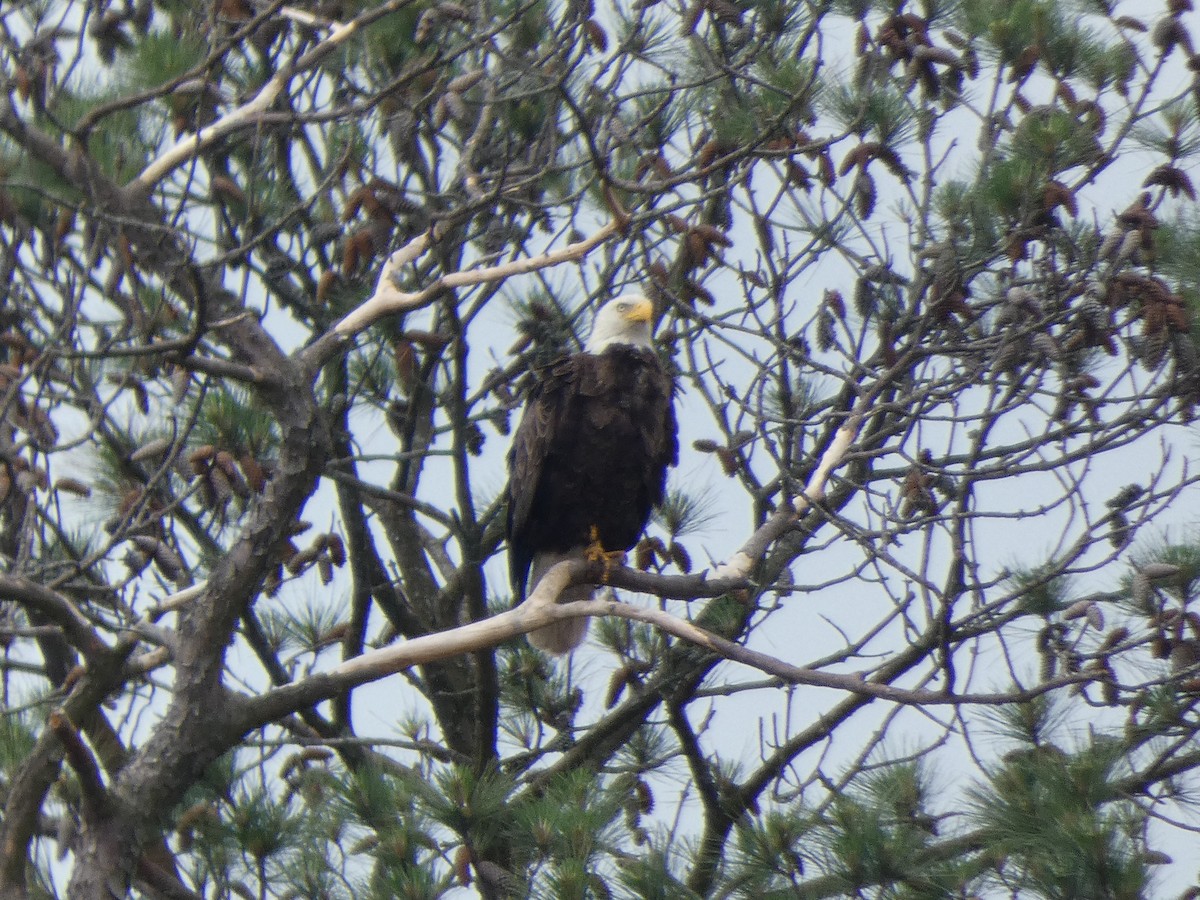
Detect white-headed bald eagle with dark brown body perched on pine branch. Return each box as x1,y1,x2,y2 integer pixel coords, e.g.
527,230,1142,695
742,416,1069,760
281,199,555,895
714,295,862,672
508,294,679,653
